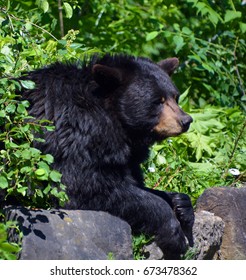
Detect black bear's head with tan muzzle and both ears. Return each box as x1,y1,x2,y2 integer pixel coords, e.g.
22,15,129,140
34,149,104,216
92,56,192,140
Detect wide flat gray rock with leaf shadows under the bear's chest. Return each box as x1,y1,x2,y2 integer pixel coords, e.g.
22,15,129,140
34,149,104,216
5,207,132,260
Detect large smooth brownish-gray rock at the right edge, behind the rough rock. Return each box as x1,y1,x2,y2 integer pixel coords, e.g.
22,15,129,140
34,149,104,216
197,187,246,260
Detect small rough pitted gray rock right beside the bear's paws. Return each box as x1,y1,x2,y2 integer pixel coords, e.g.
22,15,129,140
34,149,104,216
192,211,224,260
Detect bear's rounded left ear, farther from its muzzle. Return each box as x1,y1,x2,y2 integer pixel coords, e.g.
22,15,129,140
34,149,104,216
92,64,123,88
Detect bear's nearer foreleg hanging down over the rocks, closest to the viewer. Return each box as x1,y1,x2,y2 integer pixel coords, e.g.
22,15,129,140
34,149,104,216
107,186,187,259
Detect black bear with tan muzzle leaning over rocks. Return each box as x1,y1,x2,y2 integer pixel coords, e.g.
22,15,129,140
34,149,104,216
21,54,194,259
